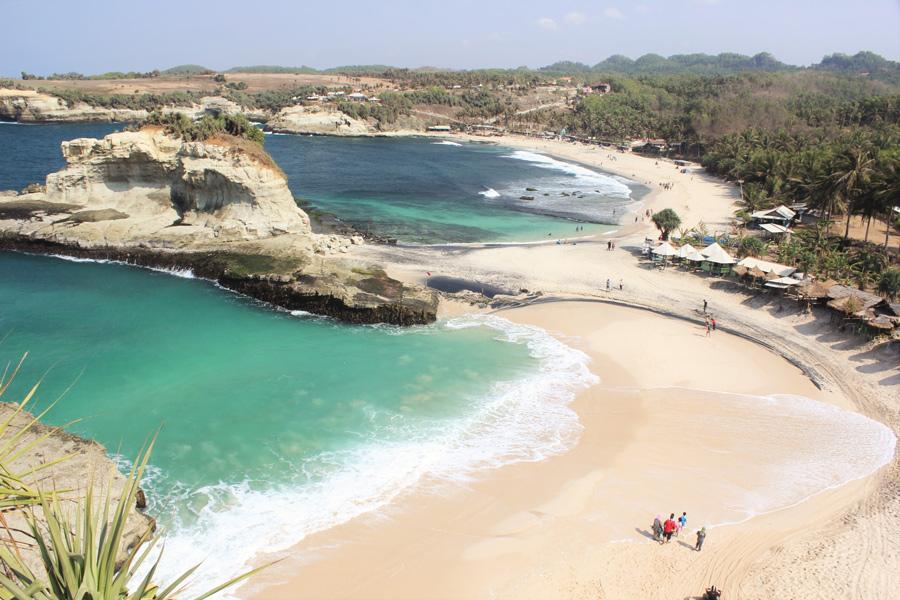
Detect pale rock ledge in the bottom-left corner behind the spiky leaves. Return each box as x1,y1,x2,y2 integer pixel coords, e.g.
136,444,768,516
0,402,156,573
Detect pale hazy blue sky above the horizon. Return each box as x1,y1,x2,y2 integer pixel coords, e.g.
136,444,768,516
0,0,900,75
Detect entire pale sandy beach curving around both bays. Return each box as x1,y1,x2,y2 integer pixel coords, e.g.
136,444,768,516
239,137,900,599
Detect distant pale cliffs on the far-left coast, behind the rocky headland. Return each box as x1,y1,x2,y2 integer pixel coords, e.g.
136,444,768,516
0,89,243,123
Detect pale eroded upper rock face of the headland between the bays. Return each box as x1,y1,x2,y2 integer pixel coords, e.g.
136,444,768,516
19,129,310,244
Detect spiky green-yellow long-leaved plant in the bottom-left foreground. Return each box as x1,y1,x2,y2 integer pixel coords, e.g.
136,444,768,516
0,438,268,600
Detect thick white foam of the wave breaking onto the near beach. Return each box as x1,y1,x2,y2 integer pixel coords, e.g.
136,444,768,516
149,315,597,591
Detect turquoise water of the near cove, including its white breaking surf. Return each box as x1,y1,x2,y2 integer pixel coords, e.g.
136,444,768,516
0,253,590,577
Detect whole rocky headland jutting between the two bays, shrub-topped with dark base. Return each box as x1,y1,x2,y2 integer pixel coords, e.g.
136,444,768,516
0,115,437,325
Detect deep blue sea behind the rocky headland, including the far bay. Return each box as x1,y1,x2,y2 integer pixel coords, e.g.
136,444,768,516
0,123,645,244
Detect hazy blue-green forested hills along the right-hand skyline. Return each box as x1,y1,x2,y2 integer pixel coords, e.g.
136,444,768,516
539,52,900,78
